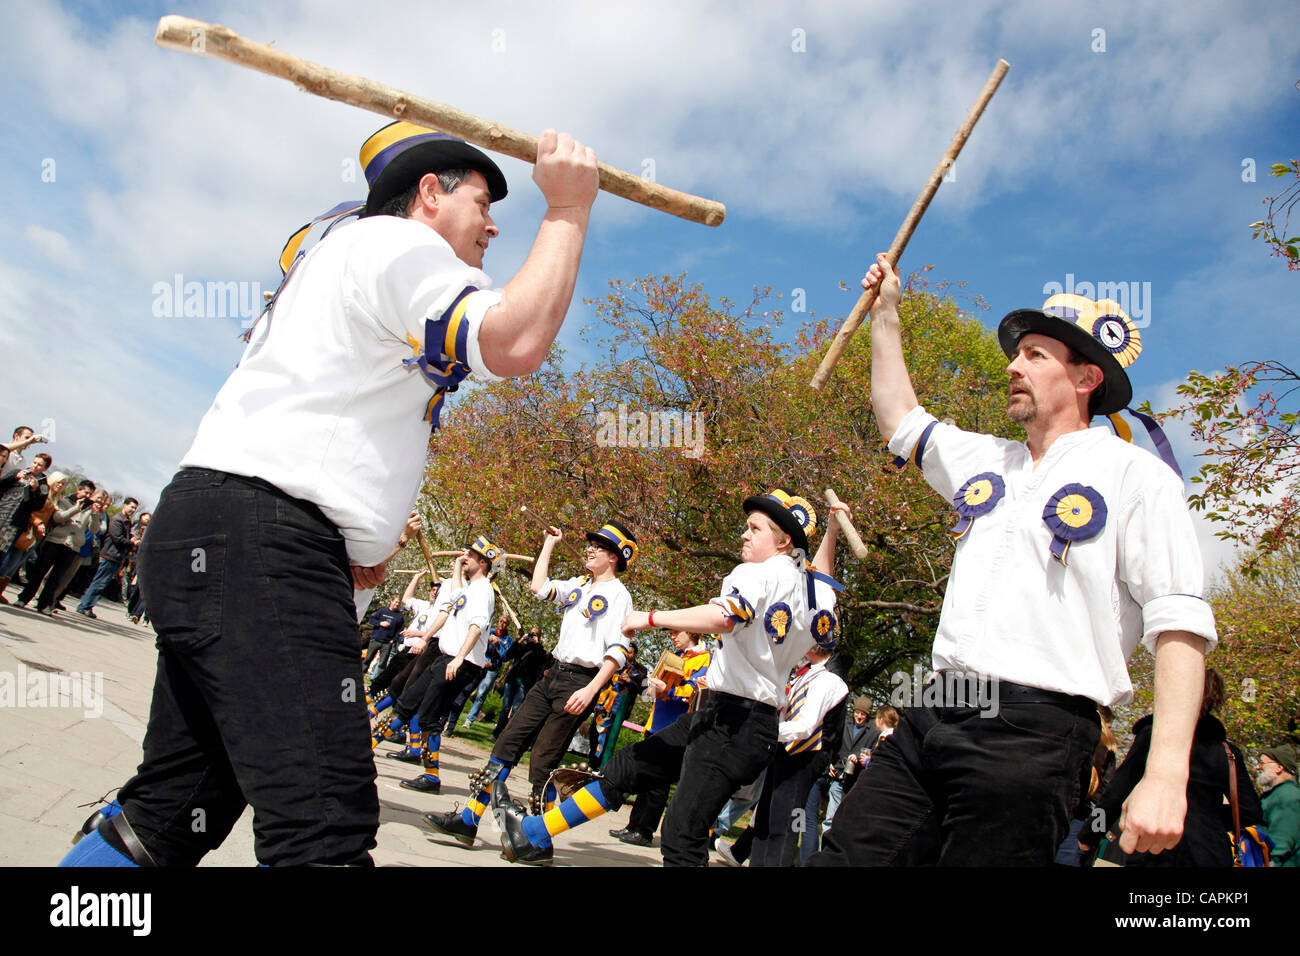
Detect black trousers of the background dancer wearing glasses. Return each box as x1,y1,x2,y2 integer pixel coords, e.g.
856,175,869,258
491,663,597,787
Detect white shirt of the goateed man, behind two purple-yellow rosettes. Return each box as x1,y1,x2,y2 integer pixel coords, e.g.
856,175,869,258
889,407,1217,705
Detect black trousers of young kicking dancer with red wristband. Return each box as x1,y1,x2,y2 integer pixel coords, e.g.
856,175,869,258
601,692,777,866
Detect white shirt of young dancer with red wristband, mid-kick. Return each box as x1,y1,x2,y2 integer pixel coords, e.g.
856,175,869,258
709,554,835,708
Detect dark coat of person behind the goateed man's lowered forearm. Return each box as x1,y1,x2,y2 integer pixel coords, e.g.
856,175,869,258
1079,714,1264,866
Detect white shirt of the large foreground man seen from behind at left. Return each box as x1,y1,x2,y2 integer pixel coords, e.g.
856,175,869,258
181,216,501,567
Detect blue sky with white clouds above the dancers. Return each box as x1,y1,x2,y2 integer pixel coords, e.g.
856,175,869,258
0,3,1300,574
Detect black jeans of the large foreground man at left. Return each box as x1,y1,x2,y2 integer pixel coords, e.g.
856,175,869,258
120,470,380,866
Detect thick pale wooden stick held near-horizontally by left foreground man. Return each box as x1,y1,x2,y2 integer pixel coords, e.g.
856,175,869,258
153,16,727,226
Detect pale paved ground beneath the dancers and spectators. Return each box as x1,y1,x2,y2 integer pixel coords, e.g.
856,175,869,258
0,588,660,866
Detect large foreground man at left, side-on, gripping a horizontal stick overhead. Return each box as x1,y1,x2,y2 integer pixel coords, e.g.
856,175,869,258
65,122,598,866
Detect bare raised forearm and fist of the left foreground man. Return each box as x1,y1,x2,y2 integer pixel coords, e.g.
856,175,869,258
478,130,599,377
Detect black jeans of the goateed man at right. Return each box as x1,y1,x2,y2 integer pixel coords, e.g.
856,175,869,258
809,700,1101,866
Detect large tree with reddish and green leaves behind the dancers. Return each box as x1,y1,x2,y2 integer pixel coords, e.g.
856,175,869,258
410,269,1014,688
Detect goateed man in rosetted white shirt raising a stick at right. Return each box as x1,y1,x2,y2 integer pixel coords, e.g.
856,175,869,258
810,254,1217,866
